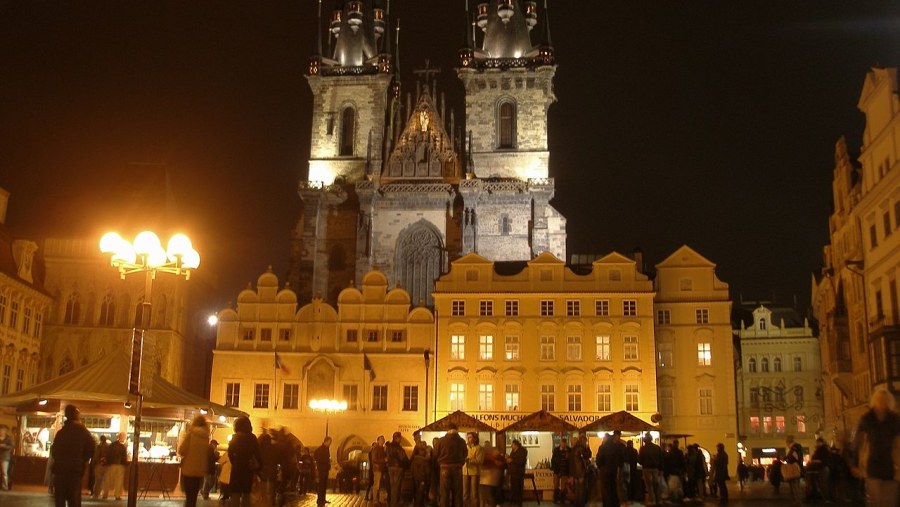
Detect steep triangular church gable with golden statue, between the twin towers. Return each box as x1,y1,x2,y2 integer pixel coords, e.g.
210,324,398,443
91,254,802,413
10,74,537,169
385,87,459,180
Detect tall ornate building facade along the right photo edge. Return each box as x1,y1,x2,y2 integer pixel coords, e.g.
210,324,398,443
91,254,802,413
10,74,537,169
812,68,900,443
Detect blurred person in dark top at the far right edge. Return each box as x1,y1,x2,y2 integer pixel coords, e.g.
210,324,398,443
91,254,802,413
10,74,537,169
854,388,900,507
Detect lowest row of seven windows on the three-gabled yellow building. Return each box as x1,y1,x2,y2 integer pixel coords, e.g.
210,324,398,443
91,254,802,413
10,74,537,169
450,382,641,412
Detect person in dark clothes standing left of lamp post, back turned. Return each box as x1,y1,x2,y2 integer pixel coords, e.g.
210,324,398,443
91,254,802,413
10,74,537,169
50,405,95,507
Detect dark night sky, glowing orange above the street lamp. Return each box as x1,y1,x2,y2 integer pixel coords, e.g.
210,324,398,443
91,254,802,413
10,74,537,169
0,0,900,305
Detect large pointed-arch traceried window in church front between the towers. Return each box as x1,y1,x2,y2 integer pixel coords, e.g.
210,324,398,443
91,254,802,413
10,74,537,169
396,220,443,306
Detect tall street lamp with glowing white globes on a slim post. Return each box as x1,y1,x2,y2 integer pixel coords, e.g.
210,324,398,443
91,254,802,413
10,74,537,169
100,231,200,507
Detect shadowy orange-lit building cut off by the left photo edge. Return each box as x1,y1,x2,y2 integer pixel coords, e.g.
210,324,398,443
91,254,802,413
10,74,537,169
0,188,52,427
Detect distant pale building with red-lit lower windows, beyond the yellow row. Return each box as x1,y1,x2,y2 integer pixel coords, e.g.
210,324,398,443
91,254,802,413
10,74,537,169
735,306,824,464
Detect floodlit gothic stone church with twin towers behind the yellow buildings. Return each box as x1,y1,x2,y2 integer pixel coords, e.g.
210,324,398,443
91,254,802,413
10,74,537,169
288,0,566,306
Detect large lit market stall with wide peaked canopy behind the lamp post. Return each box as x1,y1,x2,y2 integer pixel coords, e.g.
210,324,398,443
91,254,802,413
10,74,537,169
0,351,246,489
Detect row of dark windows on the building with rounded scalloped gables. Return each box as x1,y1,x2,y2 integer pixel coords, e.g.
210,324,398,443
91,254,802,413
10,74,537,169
225,382,419,412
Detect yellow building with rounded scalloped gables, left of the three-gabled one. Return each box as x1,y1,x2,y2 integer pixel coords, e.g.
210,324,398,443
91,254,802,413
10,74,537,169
210,270,434,459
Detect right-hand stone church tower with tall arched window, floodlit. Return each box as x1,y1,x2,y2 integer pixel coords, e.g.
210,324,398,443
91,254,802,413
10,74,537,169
457,0,566,261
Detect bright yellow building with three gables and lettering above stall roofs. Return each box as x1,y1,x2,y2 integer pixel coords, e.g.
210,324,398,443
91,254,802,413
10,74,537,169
430,253,657,436
